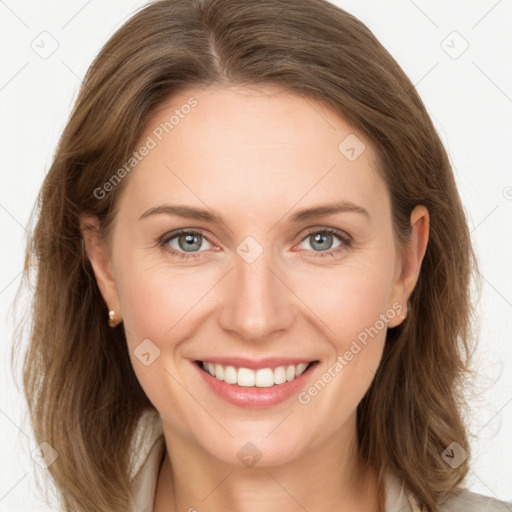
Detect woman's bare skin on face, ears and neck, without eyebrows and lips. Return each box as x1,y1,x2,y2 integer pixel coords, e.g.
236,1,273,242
82,86,429,512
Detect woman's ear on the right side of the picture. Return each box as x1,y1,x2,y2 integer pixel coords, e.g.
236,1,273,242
388,205,430,327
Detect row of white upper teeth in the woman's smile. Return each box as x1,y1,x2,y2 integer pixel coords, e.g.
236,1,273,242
202,361,309,388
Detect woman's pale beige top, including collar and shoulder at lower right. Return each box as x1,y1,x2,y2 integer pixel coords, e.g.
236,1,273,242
126,411,512,512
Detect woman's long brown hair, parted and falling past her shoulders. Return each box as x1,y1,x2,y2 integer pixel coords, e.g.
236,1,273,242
12,0,479,512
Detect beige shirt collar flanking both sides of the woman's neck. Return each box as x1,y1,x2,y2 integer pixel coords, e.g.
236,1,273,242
129,410,421,512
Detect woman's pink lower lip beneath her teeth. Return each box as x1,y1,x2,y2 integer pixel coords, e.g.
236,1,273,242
193,361,318,409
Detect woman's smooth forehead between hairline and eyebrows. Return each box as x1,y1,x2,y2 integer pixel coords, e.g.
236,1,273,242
117,87,386,224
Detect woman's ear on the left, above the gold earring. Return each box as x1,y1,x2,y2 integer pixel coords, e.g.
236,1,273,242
80,213,121,318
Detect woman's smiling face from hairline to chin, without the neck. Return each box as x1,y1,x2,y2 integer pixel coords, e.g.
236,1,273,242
81,87,426,465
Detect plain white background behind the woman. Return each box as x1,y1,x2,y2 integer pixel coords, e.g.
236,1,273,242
0,0,512,511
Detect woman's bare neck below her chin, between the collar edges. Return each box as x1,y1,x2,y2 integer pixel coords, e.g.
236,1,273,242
154,414,384,512
